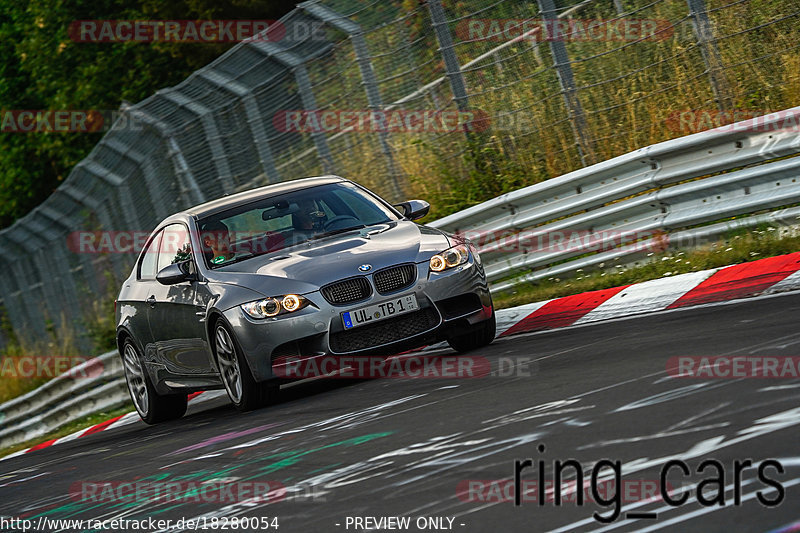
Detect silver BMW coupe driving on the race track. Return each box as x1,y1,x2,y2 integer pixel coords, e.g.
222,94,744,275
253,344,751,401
116,176,495,424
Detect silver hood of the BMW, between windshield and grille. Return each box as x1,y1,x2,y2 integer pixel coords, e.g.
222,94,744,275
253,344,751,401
207,220,451,296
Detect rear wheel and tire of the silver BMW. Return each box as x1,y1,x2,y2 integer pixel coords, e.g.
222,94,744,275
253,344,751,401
122,338,188,425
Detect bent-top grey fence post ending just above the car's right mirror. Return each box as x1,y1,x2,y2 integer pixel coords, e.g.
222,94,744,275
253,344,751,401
299,2,403,201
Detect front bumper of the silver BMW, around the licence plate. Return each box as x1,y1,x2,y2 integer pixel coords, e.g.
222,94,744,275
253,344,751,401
224,256,492,381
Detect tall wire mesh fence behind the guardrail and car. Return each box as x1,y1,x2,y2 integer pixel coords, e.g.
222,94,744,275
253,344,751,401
0,0,800,347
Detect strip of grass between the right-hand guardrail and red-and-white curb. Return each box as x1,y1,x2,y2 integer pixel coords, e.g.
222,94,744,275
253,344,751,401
493,226,800,309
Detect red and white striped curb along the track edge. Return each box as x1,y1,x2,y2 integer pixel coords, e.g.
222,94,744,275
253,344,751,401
0,252,800,461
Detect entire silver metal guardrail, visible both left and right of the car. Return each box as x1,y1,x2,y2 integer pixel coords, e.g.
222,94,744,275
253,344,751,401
0,107,800,448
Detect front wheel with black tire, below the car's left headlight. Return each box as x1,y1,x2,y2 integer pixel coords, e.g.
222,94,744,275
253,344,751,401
214,318,280,411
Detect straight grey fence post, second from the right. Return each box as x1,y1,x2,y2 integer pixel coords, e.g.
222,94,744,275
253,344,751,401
537,0,595,166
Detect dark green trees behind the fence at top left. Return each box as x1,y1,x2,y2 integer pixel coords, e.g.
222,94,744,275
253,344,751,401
0,0,294,227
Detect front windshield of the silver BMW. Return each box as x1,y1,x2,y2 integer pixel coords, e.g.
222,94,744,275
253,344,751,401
198,182,399,268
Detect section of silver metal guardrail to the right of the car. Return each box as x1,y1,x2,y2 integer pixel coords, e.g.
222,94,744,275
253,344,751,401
430,107,800,290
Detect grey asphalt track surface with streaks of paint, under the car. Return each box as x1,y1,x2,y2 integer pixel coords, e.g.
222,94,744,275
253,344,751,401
0,294,800,532
